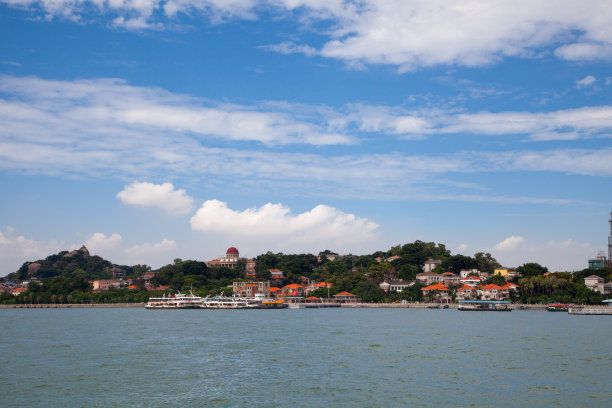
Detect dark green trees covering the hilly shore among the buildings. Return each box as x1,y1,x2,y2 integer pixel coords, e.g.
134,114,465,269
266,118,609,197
0,241,612,304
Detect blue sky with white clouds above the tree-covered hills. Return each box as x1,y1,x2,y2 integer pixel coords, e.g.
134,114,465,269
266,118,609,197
0,0,612,276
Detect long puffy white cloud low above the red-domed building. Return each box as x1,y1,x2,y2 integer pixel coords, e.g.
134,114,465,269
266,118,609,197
191,200,378,251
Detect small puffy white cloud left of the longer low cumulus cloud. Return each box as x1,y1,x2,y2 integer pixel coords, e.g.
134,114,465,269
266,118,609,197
117,181,194,214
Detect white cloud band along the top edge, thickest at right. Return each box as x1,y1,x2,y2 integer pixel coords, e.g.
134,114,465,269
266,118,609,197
7,0,612,67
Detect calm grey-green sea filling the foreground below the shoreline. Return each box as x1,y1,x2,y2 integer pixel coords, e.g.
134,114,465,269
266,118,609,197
0,308,612,408
